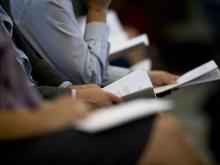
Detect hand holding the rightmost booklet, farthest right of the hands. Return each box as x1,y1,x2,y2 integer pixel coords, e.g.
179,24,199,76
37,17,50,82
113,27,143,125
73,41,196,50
148,71,178,87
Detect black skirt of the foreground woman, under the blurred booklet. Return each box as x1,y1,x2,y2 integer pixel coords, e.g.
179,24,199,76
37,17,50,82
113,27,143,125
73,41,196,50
0,116,155,165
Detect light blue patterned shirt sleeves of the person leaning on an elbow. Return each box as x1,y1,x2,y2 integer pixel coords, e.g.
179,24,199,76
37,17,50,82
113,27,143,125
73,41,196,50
11,0,129,85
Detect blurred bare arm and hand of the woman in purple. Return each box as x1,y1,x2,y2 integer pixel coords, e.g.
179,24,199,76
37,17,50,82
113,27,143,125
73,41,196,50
0,98,87,140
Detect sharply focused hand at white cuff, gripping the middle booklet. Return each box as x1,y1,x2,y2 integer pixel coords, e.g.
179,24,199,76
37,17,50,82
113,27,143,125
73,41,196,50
76,85,122,109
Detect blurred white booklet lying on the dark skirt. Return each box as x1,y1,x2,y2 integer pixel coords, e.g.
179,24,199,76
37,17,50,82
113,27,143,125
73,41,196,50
74,99,173,133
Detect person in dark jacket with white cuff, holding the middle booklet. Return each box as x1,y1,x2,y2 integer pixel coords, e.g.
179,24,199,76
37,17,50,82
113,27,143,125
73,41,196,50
0,2,121,108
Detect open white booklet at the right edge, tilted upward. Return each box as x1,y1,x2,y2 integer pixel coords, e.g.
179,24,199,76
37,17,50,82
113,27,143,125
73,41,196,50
154,60,218,94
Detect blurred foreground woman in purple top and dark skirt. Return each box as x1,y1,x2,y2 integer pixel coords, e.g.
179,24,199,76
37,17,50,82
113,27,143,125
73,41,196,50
0,25,202,165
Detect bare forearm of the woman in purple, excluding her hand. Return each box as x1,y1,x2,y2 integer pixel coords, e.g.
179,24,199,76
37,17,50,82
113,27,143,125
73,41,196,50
0,107,68,140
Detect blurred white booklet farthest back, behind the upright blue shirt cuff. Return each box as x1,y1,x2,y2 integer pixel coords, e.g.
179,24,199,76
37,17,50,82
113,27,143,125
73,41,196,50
77,10,149,60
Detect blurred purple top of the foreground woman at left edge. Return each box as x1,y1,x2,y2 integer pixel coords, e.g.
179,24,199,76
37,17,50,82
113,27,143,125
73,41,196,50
0,25,40,109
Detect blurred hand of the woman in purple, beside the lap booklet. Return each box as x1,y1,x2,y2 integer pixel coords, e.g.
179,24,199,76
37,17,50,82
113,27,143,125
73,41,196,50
39,97,89,129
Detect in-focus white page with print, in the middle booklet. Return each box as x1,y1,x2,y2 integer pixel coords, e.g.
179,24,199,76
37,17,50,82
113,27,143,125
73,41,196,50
103,70,153,97
